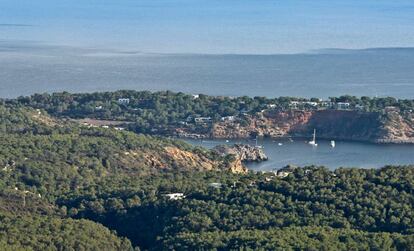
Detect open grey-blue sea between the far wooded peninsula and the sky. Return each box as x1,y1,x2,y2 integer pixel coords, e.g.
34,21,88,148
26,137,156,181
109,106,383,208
0,46,414,98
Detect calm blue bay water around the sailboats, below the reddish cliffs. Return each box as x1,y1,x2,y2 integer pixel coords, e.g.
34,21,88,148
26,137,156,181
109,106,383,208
186,139,414,171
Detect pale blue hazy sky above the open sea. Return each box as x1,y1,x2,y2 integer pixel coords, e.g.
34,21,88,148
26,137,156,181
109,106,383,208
0,0,414,54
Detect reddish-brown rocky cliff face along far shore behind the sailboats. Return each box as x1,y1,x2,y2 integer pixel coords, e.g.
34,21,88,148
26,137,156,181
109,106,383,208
212,110,414,143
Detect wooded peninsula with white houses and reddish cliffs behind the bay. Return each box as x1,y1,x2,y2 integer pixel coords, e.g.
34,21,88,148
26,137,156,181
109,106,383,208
12,91,414,144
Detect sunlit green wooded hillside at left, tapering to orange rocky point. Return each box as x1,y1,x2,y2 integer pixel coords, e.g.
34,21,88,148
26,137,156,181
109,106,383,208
0,105,239,250
